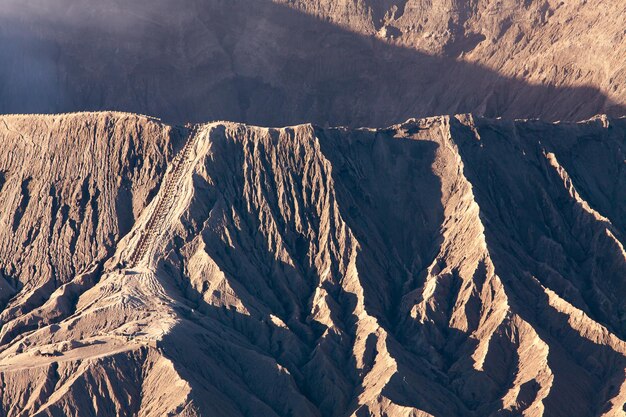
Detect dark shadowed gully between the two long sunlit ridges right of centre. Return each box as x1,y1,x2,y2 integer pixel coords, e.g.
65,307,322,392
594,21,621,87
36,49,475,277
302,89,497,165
316,125,468,416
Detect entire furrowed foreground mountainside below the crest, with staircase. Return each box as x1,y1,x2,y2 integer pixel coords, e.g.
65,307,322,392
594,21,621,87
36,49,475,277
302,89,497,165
0,114,626,417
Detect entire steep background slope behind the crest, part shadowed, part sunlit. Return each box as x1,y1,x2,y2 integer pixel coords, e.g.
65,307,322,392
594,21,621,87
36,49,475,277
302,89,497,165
0,0,626,127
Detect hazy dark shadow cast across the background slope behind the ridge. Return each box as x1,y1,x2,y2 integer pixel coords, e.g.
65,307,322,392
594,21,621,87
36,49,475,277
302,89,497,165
0,0,626,126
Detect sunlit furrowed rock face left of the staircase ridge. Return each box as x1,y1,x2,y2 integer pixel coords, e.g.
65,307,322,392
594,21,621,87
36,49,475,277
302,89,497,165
0,113,183,341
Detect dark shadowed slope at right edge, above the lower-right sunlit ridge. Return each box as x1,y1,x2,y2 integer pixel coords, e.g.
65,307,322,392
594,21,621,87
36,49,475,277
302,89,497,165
454,115,626,338
